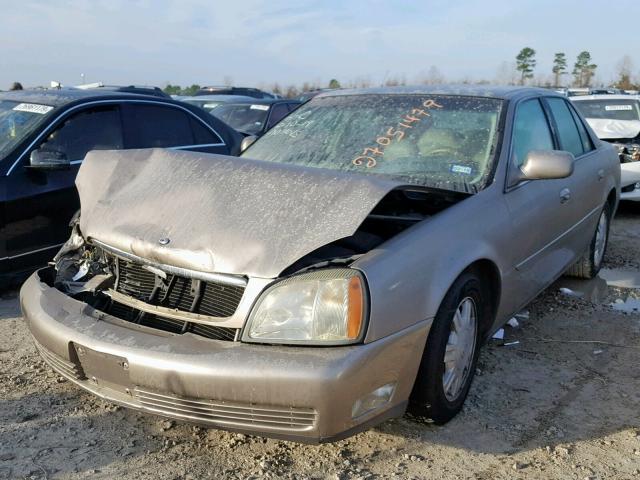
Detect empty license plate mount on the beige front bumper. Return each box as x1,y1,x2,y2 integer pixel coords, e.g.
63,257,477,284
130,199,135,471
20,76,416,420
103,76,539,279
73,343,131,393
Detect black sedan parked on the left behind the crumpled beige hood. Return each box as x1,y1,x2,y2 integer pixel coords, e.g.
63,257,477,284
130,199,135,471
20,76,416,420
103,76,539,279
0,89,242,285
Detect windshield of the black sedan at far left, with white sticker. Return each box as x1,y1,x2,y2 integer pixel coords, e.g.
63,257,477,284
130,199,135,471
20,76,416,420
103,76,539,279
0,100,53,159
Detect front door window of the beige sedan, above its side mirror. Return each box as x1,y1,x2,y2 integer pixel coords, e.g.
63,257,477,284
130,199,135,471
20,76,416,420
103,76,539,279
512,99,554,167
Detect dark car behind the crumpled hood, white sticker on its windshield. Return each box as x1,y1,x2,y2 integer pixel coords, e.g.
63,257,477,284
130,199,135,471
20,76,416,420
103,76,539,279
209,99,302,137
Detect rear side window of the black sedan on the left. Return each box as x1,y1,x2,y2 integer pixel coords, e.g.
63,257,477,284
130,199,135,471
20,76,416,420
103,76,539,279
125,104,195,148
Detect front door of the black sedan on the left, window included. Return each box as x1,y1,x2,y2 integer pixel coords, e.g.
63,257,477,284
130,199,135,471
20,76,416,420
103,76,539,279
3,105,123,278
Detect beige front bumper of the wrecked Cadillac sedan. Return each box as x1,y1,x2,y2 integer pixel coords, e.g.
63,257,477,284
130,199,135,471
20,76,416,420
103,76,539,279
20,272,430,443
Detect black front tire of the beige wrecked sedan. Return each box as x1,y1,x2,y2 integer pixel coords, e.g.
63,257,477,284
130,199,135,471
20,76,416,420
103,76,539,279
409,272,490,425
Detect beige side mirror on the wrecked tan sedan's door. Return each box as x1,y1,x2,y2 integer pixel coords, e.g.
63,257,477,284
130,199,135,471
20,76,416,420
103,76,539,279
509,150,574,185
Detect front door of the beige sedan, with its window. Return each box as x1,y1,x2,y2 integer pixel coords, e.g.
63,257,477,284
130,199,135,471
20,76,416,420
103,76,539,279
504,98,581,309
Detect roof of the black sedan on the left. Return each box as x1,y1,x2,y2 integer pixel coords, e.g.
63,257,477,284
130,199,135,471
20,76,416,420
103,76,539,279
0,88,171,107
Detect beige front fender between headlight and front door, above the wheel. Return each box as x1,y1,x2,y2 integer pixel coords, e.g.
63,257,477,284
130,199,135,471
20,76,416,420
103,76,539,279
353,189,509,342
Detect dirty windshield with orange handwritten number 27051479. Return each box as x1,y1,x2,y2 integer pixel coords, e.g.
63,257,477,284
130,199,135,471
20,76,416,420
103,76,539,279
242,94,503,192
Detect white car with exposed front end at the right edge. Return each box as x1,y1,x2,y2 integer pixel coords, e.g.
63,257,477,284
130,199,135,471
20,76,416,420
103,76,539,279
571,94,640,201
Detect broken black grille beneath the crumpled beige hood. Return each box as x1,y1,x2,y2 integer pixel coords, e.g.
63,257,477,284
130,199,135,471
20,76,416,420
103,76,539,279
105,252,244,341
